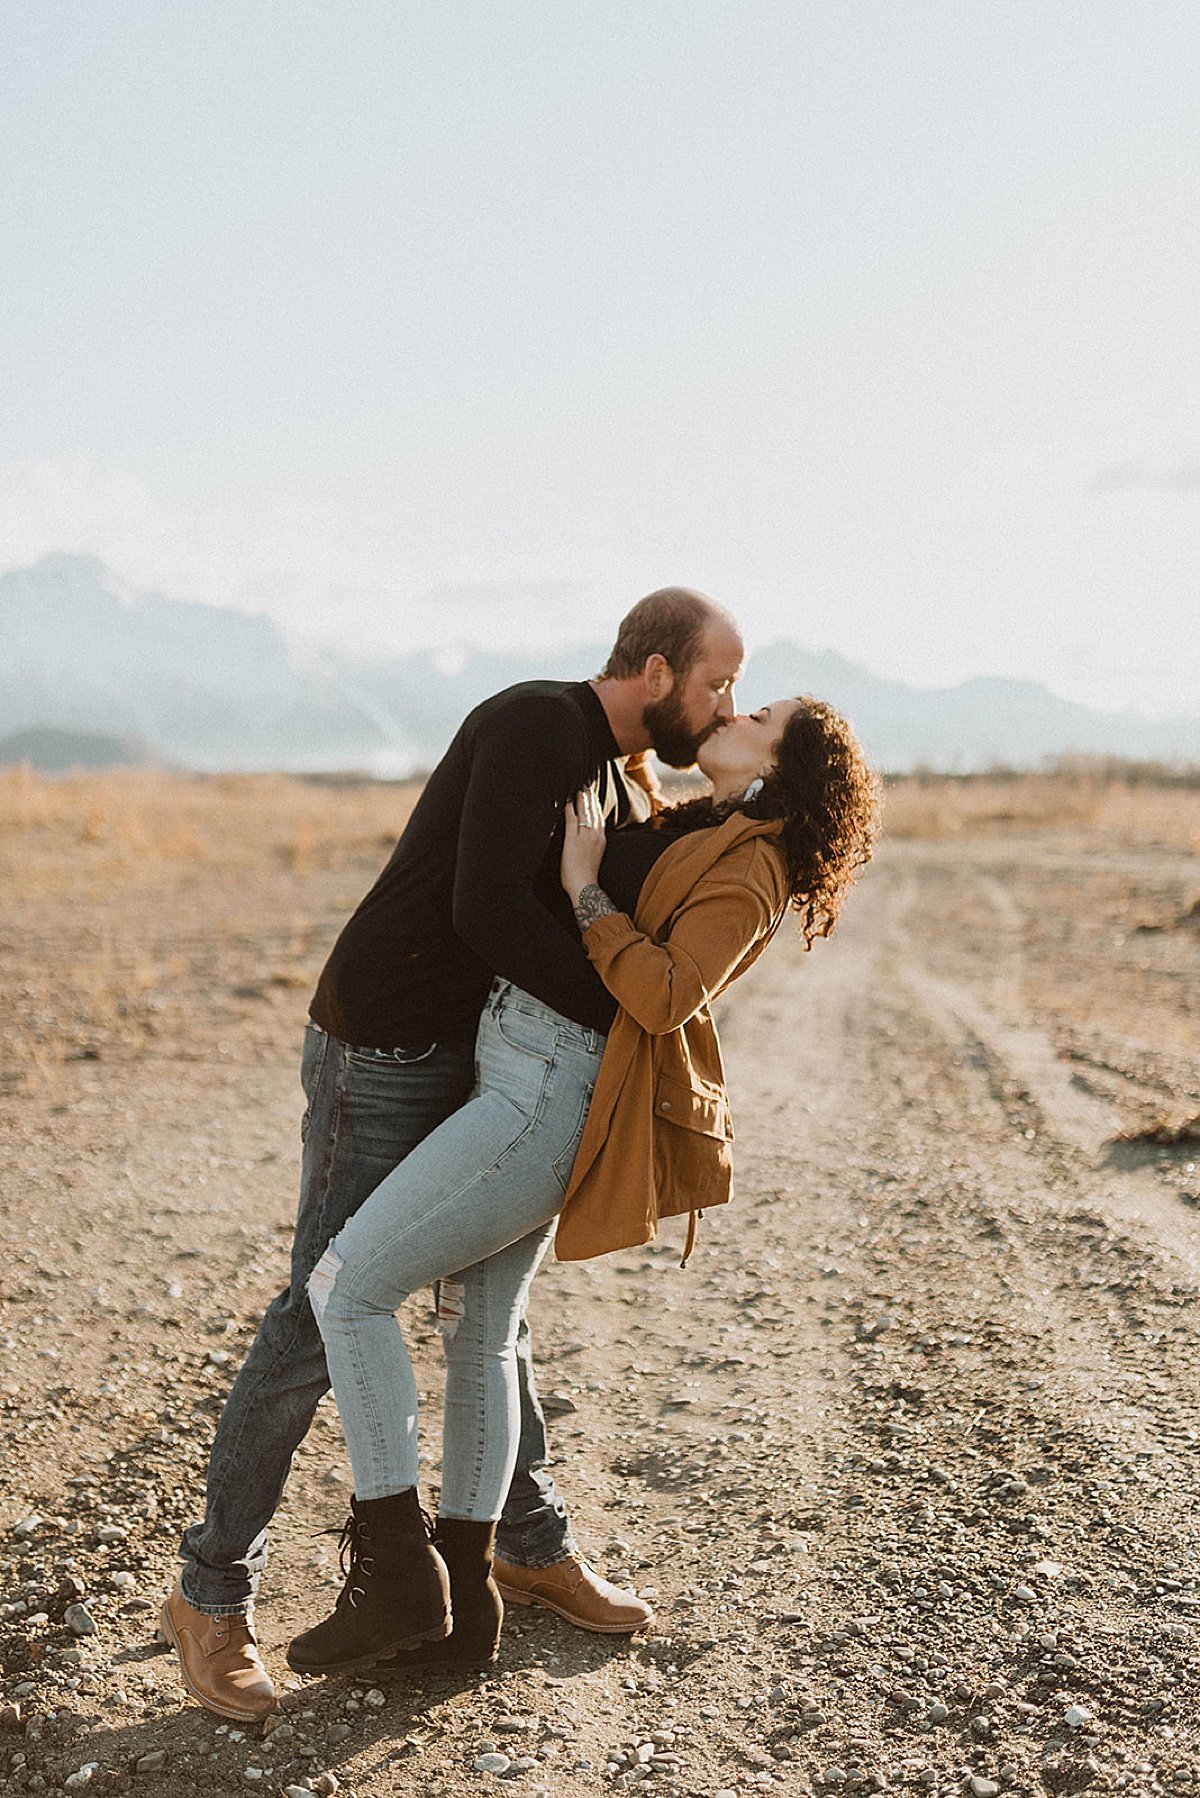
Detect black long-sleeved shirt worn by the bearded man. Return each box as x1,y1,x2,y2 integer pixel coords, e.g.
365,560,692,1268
309,681,649,1048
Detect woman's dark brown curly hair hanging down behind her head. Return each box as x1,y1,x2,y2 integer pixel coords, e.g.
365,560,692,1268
655,696,880,949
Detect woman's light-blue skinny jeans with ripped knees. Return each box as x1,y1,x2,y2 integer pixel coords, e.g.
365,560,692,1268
308,982,604,1521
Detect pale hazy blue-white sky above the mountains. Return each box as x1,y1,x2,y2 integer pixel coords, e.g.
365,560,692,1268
0,0,1200,712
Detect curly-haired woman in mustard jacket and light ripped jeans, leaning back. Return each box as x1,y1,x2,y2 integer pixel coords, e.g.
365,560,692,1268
288,699,878,1672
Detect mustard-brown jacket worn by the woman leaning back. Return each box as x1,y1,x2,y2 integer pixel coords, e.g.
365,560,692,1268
554,813,788,1260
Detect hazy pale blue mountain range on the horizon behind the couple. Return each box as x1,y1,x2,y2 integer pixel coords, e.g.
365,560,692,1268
0,554,1200,775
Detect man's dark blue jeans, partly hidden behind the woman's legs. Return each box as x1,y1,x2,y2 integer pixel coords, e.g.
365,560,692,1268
182,1025,576,1616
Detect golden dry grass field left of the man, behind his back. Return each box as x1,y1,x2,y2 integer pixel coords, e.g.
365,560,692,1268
0,768,419,1088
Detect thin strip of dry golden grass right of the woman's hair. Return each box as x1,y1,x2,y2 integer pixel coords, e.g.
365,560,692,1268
883,770,1200,852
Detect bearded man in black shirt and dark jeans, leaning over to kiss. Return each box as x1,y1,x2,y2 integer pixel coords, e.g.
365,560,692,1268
162,588,743,1721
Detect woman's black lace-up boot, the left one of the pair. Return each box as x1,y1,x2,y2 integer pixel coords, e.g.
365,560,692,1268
288,1487,450,1674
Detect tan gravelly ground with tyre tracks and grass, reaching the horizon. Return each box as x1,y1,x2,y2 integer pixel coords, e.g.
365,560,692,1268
0,783,1200,1798
